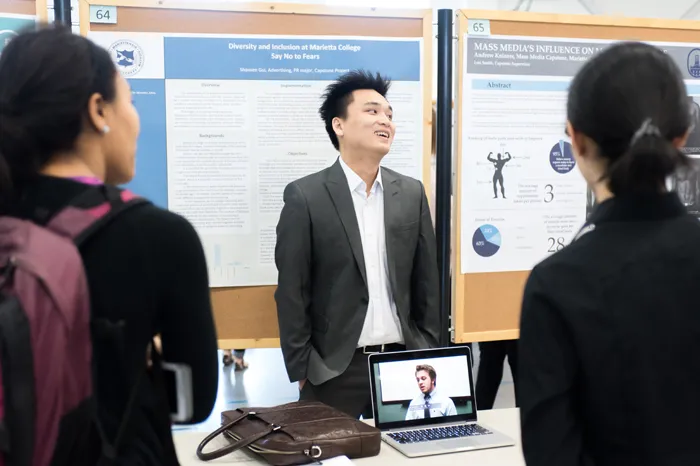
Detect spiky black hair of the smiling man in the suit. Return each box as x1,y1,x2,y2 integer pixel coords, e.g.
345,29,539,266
318,70,391,150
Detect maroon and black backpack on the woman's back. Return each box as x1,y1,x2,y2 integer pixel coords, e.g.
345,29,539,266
0,185,148,466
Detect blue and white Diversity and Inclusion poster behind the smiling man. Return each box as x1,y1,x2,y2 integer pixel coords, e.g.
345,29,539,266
89,32,423,287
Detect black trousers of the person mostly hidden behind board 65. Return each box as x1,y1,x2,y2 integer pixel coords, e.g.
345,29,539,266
476,340,518,410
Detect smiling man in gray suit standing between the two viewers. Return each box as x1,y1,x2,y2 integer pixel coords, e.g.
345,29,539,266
275,71,440,417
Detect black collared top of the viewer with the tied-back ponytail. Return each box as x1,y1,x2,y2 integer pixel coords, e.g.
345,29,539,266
518,190,700,466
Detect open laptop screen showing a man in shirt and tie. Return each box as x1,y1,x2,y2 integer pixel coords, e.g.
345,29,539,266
369,347,476,429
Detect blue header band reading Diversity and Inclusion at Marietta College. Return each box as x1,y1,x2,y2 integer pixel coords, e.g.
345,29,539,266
164,37,421,81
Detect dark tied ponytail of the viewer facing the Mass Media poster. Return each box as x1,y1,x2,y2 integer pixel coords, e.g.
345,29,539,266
606,118,688,194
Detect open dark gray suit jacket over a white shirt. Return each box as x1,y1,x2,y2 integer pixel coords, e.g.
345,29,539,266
275,161,440,385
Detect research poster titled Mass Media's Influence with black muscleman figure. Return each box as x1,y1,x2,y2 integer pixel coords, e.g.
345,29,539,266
460,35,700,273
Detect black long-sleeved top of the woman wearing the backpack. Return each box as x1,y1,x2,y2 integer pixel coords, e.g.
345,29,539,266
15,177,218,466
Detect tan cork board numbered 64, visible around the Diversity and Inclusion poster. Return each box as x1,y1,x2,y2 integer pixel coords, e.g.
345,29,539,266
80,0,432,348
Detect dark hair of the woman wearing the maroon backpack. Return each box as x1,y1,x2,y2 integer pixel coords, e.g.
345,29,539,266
0,24,117,211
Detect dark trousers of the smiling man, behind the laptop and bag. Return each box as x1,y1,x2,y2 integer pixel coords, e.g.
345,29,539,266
299,345,405,419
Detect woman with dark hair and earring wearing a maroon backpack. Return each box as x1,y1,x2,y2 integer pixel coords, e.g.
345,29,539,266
0,26,218,466
